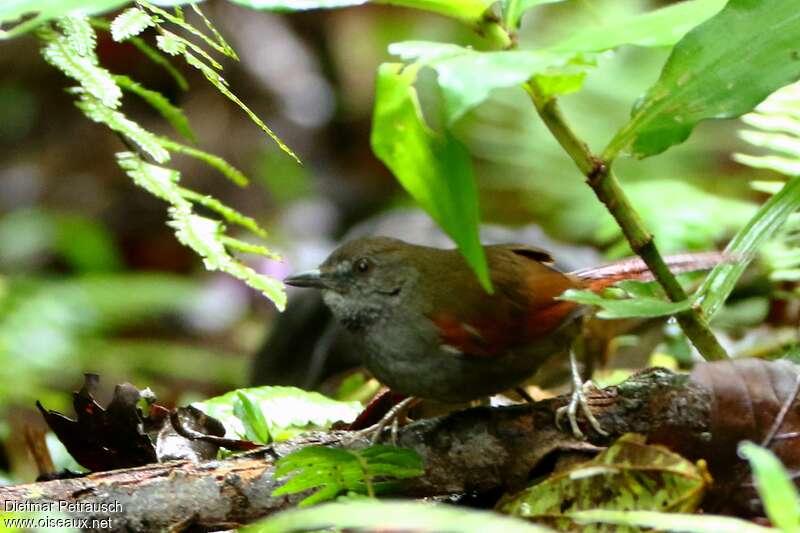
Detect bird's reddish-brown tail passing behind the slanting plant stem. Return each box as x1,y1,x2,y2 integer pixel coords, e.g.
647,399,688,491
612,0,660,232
571,252,731,291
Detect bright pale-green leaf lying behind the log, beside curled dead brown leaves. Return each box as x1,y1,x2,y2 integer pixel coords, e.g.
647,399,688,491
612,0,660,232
192,386,362,440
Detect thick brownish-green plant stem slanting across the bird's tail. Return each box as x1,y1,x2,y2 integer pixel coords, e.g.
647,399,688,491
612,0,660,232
525,82,728,361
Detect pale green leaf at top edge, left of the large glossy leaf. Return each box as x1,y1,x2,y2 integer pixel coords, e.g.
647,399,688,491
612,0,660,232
551,0,727,52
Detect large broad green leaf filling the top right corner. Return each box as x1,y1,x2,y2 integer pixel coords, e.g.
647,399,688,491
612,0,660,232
603,0,800,161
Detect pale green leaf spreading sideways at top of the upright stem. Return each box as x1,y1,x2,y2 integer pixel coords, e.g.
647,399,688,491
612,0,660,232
389,41,589,127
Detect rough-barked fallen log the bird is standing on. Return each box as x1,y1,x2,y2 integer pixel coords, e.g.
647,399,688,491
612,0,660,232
0,360,800,532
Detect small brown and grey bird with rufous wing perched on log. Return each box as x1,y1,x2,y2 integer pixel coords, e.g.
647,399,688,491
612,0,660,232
284,237,724,436
